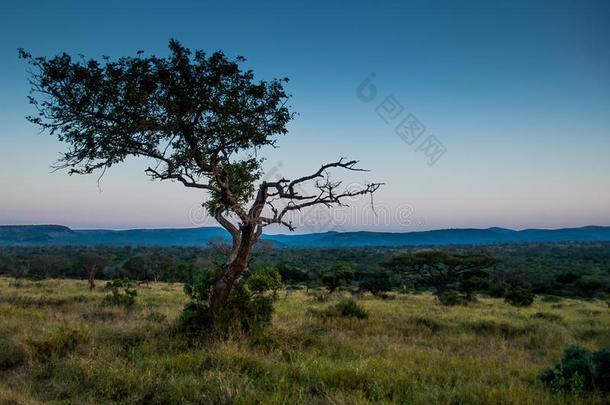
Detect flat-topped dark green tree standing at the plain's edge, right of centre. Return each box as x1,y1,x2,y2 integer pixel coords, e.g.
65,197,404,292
384,250,496,303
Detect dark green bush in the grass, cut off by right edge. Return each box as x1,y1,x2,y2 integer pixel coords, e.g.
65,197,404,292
539,345,610,393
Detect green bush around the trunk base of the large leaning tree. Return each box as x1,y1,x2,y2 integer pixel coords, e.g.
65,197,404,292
177,267,283,335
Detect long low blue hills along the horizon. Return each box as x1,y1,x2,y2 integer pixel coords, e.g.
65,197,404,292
0,225,610,248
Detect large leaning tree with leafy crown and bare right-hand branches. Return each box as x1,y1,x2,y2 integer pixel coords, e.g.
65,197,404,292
20,40,381,315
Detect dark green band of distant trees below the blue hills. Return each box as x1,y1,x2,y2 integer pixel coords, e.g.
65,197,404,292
0,243,610,303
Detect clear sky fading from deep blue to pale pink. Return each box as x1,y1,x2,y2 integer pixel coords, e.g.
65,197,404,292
0,0,610,232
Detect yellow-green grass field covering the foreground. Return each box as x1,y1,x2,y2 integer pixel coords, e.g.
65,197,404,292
0,278,610,405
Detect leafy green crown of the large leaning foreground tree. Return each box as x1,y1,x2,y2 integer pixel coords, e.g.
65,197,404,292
19,40,292,215
